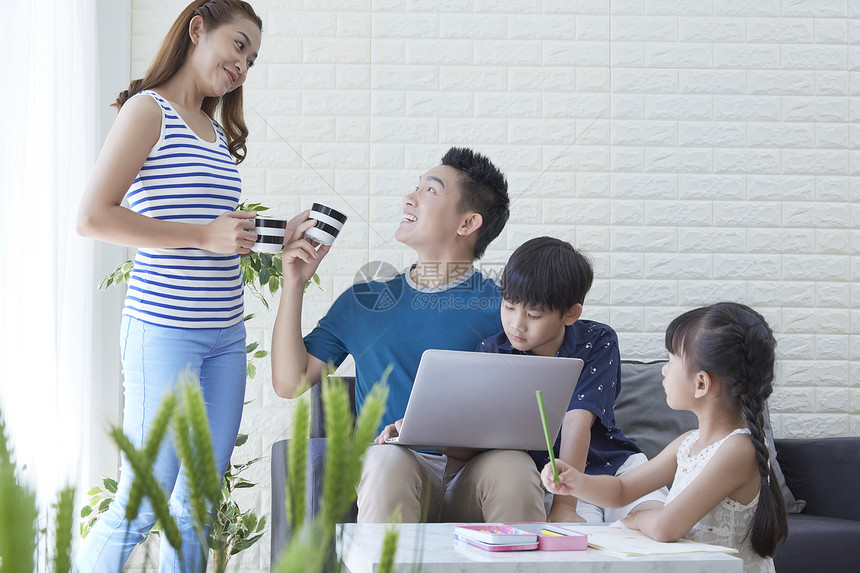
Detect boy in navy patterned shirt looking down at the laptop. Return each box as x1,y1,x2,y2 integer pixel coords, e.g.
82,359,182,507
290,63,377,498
478,237,666,522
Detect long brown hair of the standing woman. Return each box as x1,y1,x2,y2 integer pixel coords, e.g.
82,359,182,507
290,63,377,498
113,0,263,164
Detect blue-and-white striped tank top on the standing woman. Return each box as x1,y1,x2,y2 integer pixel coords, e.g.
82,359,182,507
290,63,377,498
123,90,243,328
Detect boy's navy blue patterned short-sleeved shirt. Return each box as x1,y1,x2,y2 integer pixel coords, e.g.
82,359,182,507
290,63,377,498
477,320,641,475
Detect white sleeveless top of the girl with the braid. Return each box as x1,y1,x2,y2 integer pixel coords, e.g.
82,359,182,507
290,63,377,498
666,428,775,573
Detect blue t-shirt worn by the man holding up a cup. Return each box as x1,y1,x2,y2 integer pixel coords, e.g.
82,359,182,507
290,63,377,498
304,269,502,429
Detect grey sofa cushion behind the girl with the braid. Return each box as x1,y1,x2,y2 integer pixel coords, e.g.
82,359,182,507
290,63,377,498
615,360,803,513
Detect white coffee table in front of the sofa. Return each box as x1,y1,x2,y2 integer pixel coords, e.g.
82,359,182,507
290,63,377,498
338,523,743,573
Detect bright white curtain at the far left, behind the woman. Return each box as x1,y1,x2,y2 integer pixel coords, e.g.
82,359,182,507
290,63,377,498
0,0,98,507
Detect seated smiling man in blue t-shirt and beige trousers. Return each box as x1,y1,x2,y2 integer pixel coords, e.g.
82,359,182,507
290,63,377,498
272,148,546,522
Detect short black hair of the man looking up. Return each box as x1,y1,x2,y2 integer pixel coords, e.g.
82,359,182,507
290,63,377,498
442,147,511,260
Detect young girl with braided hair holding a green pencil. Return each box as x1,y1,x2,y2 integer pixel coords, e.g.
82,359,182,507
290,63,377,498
541,302,787,572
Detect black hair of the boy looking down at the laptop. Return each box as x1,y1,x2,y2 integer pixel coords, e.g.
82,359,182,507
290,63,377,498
500,237,594,314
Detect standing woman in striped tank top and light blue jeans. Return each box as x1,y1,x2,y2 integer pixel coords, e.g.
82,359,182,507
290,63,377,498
75,0,262,573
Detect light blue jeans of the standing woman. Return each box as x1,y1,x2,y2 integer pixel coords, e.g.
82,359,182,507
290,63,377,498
75,316,247,573
